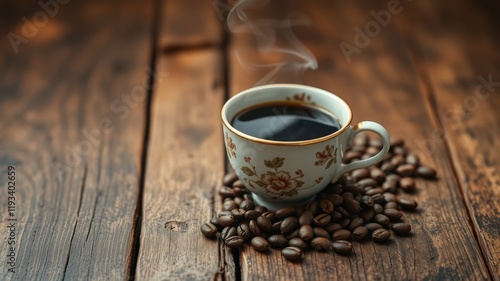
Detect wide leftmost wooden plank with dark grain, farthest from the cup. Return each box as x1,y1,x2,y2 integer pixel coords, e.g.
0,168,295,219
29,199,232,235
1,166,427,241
0,1,152,280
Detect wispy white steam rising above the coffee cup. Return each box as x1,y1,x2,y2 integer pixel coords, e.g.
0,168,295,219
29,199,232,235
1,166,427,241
227,0,318,86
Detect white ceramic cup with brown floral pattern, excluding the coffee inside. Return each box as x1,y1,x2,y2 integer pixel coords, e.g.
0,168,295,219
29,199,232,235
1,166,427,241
221,84,390,210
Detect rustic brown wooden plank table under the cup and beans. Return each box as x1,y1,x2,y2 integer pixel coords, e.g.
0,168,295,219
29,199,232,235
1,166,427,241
0,0,500,280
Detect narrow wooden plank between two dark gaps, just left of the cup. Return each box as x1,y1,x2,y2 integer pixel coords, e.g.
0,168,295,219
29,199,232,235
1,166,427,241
137,1,229,280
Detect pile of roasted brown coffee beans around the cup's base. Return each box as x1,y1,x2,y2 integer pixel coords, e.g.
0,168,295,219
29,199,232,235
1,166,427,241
201,134,436,261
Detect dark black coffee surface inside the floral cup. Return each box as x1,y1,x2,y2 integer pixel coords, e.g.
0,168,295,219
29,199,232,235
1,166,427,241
232,103,340,141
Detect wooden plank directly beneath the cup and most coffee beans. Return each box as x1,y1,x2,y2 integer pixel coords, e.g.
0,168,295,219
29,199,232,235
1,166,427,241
230,1,489,280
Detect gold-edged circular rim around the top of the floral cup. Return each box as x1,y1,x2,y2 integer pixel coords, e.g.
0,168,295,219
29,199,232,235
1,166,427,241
221,84,352,146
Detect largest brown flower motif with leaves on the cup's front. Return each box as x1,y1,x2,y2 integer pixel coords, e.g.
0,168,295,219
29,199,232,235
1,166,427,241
241,156,323,199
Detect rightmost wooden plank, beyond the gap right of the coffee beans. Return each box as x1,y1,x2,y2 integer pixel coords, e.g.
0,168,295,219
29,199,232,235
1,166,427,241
396,1,500,280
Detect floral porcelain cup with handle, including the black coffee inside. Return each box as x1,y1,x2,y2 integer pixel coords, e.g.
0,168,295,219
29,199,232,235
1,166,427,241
221,84,390,210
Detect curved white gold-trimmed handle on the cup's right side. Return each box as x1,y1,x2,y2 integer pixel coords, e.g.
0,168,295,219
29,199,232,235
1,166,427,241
338,121,391,176
